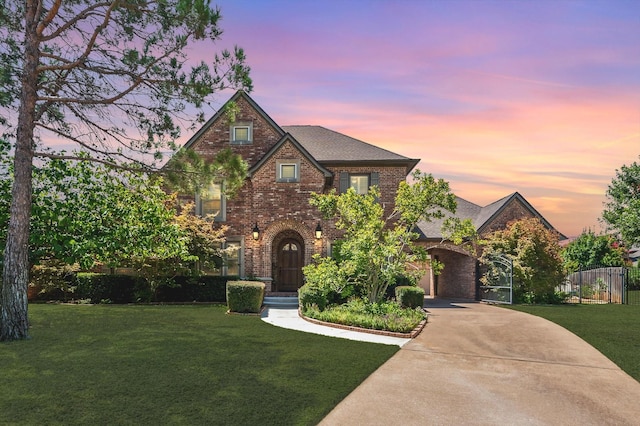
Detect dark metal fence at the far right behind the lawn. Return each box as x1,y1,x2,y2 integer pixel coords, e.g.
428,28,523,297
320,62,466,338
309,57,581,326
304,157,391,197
559,266,640,305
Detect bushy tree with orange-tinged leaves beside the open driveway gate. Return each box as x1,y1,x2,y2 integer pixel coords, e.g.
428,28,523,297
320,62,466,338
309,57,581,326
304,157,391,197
480,218,564,303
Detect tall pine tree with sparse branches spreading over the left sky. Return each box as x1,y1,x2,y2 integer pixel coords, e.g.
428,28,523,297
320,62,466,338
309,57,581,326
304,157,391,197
0,0,251,340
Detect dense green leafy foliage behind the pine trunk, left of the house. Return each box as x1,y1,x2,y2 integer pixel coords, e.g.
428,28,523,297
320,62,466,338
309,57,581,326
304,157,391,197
0,147,227,296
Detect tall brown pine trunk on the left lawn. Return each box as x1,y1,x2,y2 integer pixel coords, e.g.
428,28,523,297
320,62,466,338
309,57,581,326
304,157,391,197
0,1,39,341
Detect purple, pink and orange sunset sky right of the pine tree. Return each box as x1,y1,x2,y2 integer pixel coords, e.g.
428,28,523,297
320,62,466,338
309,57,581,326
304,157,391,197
186,0,640,236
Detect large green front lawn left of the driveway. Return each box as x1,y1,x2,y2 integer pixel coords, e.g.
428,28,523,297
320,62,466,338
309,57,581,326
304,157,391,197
0,305,398,425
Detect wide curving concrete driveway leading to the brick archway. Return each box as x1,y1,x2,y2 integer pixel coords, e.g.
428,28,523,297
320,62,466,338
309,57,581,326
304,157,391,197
321,301,640,425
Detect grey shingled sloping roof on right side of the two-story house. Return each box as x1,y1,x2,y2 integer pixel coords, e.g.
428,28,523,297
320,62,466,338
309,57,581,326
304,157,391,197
282,126,419,171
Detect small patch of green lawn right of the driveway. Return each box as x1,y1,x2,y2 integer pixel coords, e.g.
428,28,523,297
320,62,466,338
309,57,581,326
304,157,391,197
510,305,640,381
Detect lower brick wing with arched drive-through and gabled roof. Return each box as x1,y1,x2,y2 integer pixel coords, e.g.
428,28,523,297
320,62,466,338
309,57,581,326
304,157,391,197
418,192,566,299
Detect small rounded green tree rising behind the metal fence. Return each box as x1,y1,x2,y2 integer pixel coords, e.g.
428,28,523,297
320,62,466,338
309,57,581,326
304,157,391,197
560,230,625,272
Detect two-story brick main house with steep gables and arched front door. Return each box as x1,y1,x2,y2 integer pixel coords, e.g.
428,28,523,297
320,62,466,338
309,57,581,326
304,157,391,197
185,91,419,292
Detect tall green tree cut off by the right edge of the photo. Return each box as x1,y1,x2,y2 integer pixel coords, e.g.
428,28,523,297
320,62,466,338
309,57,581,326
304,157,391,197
602,158,640,247
